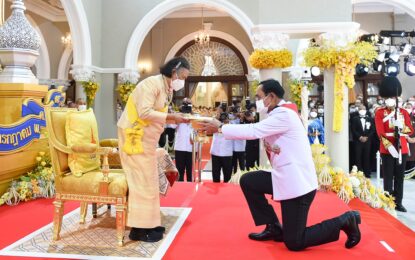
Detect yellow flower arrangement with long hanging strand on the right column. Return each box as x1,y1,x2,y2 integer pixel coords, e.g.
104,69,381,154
304,42,377,132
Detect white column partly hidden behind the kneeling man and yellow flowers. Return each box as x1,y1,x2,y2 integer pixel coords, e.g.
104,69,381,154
252,31,289,167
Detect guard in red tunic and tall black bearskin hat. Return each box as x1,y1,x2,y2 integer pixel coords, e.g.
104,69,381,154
375,76,414,212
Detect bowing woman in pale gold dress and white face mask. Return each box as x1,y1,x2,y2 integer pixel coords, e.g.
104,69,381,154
117,57,190,242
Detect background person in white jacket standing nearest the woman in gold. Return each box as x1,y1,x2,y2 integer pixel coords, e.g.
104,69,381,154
174,103,193,182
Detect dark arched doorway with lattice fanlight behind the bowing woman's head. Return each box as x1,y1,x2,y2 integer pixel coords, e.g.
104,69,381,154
175,37,248,107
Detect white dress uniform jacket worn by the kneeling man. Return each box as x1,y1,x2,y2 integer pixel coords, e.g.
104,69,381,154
222,101,318,200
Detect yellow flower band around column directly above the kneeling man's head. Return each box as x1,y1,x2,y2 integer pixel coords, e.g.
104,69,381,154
249,49,293,69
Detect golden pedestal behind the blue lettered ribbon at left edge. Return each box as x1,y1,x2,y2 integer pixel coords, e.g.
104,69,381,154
0,83,48,195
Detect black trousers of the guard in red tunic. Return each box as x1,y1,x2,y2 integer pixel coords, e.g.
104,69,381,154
381,154,408,205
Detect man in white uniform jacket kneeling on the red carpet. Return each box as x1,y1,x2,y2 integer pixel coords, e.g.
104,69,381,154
203,80,361,251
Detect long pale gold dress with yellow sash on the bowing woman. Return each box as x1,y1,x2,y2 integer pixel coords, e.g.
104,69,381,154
117,75,171,228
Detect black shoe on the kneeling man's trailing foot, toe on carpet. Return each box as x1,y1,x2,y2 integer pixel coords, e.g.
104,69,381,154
339,211,361,248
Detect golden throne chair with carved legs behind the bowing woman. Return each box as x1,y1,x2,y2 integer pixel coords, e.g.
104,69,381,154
46,108,128,246
